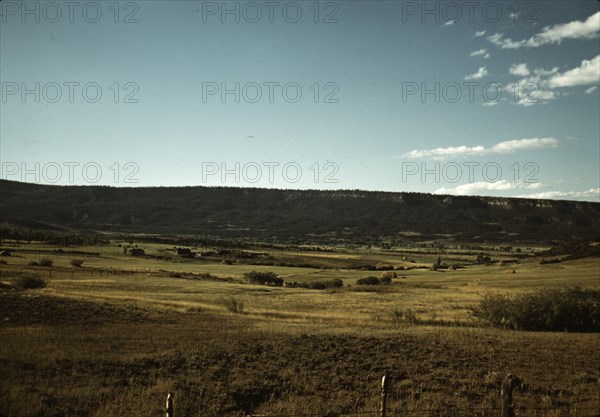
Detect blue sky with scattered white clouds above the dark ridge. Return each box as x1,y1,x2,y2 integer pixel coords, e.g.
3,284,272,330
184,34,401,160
0,1,600,201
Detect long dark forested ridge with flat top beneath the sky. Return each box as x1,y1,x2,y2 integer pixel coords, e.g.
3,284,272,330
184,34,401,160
0,180,600,243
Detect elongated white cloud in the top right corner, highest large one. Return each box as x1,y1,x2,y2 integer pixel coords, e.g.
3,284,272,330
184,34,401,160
487,12,600,49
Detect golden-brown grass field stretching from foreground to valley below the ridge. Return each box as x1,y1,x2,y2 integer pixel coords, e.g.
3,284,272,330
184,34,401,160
0,242,600,417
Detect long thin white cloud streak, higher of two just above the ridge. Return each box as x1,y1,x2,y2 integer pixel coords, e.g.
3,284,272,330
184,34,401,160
402,138,559,159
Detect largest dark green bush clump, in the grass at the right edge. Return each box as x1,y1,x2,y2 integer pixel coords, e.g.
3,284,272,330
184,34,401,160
470,287,600,332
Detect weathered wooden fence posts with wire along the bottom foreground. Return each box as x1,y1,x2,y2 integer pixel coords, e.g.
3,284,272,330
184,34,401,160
166,374,548,417
